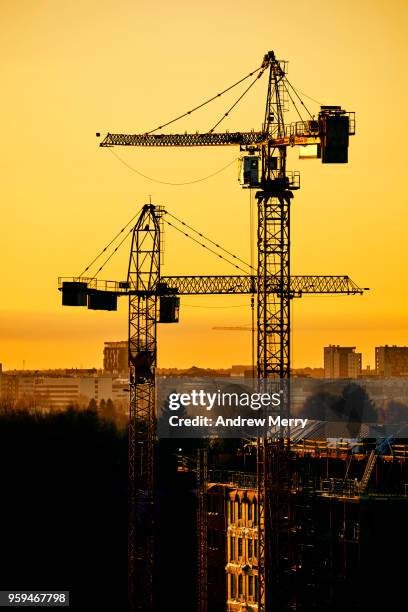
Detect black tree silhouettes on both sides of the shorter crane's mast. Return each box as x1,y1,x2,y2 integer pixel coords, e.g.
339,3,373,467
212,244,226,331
0,406,197,612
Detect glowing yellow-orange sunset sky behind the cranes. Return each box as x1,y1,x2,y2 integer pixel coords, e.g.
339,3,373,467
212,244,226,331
0,0,408,369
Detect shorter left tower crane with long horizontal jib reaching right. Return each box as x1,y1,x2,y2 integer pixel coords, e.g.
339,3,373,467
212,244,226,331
58,216,364,611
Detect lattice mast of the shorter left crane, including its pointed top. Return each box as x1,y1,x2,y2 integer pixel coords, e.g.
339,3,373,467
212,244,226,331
128,205,160,611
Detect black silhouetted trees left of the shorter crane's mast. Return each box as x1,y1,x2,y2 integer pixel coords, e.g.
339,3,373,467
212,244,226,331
0,410,127,611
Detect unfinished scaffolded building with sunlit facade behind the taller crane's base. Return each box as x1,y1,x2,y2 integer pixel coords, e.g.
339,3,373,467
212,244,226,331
202,439,408,612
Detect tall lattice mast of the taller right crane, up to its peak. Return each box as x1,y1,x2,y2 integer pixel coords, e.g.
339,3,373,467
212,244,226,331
256,52,293,611
